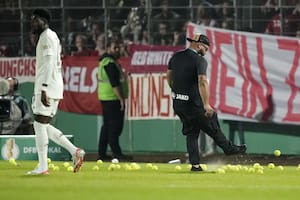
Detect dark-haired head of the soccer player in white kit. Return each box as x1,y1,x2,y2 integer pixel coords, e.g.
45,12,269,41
31,9,51,34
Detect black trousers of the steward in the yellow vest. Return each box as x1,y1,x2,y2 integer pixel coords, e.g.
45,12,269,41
98,100,124,158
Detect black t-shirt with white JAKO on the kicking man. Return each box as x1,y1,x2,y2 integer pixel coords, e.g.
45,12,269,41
168,49,207,108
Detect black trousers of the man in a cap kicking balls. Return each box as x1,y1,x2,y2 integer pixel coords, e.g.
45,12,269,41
174,104,231,165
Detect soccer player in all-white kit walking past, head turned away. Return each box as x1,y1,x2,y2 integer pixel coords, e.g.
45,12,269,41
27,9,85,175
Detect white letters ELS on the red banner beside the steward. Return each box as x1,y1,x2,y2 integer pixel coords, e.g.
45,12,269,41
64,66,98,93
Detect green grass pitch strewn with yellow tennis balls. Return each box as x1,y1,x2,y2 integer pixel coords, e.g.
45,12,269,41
0,161,300,200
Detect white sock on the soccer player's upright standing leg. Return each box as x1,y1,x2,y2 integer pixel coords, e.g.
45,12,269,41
33,121,48,171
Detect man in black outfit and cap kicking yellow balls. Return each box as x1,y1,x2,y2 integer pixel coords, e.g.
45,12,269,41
167,34,247,171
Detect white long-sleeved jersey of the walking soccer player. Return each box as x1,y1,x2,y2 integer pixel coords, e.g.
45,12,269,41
34,28,63,99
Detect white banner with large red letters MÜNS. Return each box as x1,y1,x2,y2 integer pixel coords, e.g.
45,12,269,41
128,73,174,119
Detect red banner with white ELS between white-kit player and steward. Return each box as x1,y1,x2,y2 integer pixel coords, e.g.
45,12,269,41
59,56,101,114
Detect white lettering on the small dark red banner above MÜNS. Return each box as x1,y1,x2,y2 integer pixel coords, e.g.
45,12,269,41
131,51,174,65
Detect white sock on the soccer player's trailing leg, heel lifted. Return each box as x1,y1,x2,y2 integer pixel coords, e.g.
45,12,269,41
47,124,77,155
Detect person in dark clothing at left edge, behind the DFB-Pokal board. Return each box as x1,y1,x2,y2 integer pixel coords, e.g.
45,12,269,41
0,77,33,135
